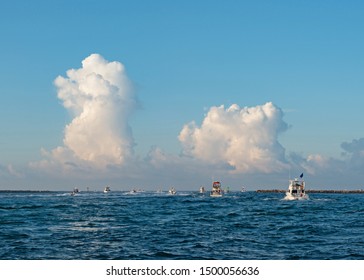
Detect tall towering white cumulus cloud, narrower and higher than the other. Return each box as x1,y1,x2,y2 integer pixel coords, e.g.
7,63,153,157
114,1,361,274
42,54,136,170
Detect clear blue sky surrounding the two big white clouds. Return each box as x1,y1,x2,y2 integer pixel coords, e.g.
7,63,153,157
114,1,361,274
0,0,364,189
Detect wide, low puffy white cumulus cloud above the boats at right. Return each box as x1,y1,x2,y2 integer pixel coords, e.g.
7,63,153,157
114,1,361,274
178,102,287,173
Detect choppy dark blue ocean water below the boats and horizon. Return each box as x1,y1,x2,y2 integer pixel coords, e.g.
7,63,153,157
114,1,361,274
0,192,364,260
